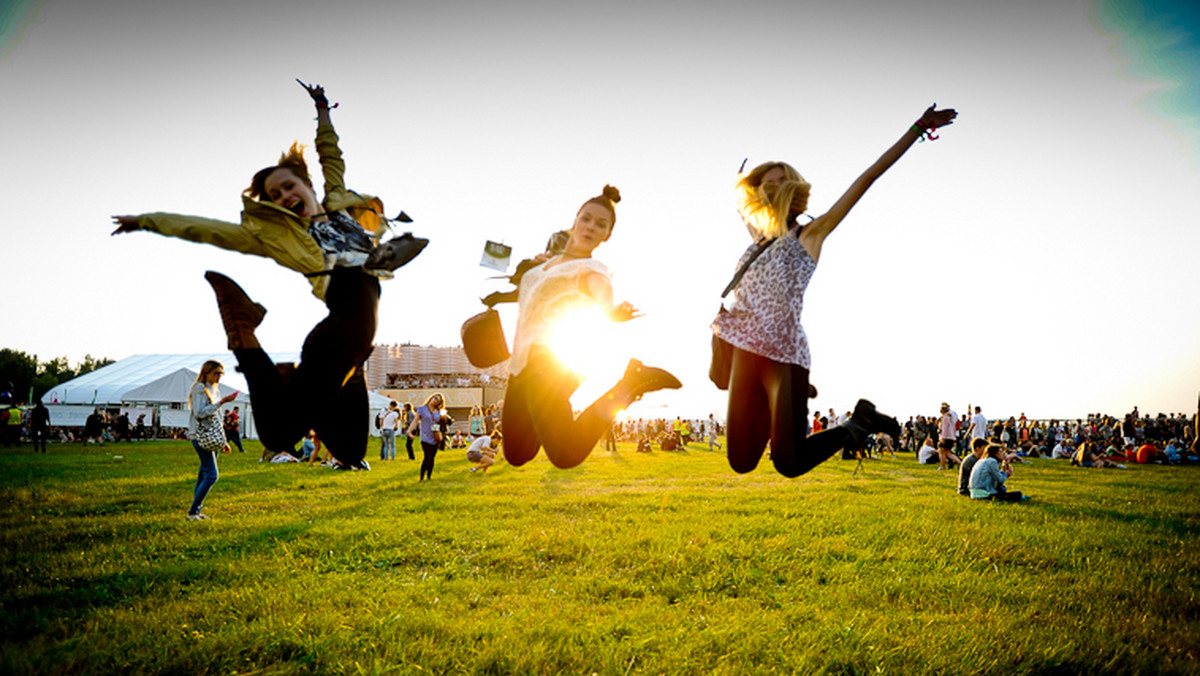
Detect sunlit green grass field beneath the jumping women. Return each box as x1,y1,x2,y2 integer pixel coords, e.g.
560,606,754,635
0,442,1200,675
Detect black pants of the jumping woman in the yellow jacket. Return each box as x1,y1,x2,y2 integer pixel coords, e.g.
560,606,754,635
234,268,379,465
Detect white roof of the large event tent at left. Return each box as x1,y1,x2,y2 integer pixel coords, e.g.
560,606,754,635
42,352,300,406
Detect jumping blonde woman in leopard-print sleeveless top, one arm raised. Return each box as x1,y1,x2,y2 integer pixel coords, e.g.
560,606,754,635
713,106,956,477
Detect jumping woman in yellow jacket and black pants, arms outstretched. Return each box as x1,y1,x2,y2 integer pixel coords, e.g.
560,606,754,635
113,83,427,466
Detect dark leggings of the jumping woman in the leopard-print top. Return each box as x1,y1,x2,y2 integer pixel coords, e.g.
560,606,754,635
724,348,853,477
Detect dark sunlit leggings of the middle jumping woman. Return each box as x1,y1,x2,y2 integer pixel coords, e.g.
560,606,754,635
502,348,629,469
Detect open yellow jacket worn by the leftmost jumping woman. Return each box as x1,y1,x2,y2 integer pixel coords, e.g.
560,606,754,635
138,125,386,300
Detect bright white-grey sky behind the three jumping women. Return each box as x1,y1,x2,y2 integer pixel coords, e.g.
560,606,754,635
0,0,1200,417
